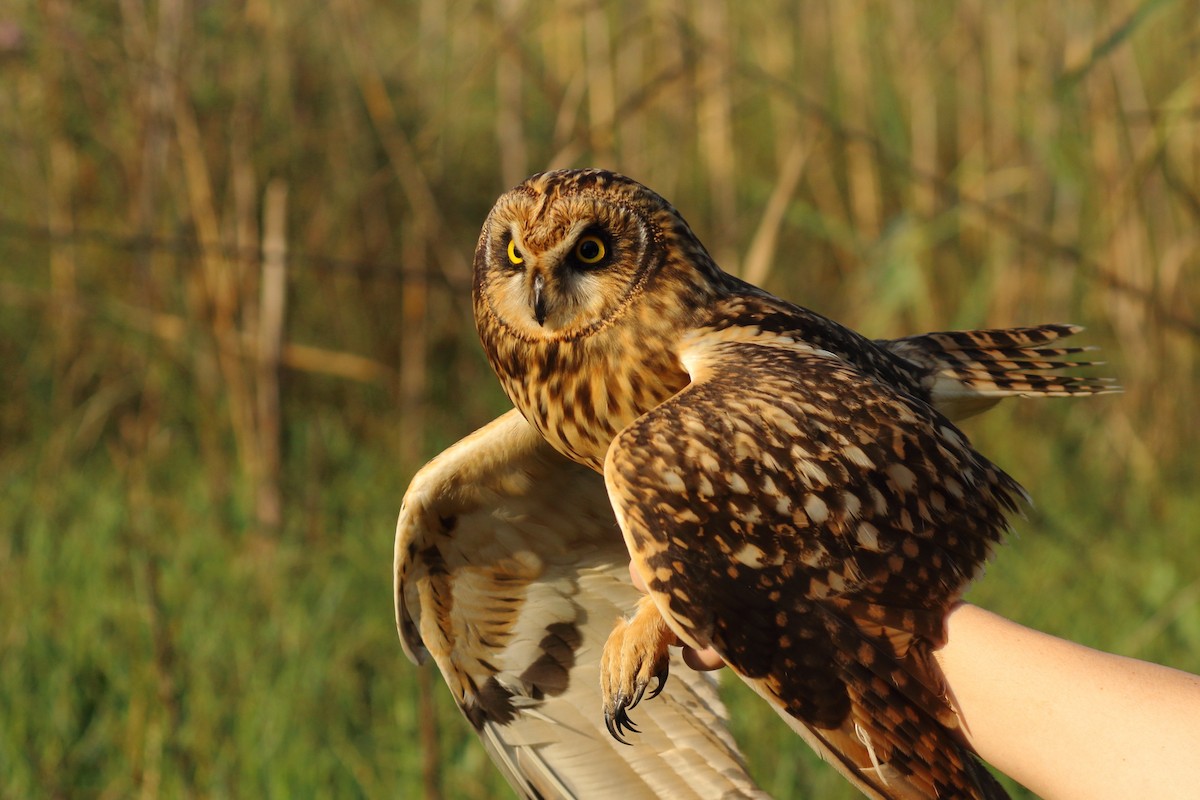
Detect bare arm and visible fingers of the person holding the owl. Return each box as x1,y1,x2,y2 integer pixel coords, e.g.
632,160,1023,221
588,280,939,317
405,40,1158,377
630,570,1200,800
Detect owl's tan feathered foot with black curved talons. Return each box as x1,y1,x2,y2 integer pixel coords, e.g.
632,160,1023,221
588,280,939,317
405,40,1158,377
600,596,676,745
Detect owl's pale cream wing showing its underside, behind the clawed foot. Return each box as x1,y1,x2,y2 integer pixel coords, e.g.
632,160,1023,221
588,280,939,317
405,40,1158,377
395,410,762,799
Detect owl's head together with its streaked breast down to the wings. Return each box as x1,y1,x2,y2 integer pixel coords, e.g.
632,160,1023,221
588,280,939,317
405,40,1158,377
472,169,724,469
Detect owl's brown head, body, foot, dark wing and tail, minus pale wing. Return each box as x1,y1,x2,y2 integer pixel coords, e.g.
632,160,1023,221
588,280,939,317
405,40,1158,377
408,165,1112,798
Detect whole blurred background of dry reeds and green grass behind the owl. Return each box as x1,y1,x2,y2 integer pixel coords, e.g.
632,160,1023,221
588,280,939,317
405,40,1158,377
0,0,1200,798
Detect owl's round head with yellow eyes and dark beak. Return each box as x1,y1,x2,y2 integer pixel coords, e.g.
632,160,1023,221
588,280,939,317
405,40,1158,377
473,169,720,341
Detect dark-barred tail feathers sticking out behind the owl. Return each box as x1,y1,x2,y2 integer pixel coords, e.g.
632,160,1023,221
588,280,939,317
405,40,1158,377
878,324,1121,420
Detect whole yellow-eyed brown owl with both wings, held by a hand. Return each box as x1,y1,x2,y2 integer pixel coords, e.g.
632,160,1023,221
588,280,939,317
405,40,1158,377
396,169,1115,798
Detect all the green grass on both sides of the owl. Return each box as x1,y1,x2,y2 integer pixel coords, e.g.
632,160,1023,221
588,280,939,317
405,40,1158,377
0,391,1200,798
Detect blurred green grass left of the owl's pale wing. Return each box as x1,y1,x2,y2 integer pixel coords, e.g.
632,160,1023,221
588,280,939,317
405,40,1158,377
0,417,503,798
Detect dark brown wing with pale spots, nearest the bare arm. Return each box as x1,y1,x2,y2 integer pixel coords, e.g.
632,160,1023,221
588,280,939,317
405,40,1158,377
605,327,1024,798
